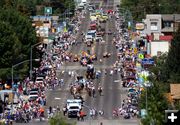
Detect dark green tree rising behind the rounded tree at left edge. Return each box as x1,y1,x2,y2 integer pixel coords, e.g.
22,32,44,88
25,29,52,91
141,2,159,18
0,8,37,57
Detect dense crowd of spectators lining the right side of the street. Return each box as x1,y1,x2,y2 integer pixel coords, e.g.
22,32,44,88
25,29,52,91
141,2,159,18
112,6,141,119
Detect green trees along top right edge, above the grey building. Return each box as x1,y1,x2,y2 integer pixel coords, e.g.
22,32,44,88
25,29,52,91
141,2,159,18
121,0,180,21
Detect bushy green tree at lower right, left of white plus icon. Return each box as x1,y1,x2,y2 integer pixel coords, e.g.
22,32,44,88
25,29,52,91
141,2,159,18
139,82,168,125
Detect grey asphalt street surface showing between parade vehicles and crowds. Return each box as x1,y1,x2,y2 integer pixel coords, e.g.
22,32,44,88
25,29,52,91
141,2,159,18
15,0,137,125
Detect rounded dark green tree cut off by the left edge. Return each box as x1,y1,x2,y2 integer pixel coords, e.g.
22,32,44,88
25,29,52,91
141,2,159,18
0,21,22,68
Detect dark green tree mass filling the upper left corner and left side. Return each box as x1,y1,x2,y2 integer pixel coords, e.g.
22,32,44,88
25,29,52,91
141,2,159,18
0,0,75,81
